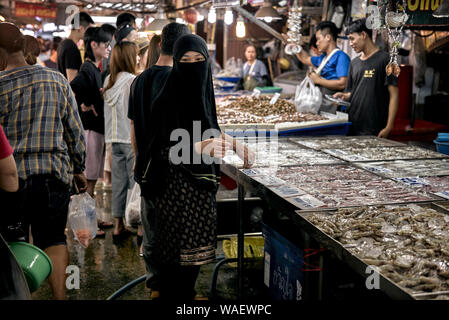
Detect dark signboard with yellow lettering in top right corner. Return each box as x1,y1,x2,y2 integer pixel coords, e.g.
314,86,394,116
406,0,449,27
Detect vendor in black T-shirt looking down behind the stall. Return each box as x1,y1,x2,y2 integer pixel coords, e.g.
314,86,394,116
334,19,399,138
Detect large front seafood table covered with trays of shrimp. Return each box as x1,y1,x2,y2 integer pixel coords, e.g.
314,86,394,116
222,136,449,299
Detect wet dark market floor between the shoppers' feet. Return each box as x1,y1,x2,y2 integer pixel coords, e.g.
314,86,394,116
33,186,250,300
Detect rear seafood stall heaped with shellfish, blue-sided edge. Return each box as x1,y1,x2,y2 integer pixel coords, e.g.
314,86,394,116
217,93,350,136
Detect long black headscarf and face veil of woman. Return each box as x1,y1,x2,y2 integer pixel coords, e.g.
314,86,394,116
151,34,220,189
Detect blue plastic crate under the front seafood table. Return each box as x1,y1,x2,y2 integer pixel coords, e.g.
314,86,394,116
262,224,304,301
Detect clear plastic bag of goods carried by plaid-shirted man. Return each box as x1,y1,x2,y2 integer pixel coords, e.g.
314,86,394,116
68,192,97,248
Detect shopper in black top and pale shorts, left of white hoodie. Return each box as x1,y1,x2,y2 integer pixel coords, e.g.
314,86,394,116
70,27,111,202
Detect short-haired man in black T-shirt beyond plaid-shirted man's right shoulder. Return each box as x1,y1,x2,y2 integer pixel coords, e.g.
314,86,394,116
58,12,94,83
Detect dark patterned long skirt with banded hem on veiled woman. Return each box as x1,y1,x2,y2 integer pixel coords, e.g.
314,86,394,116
154,164,217,266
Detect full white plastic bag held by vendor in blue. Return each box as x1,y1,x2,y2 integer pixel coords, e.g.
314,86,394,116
295,77,323,114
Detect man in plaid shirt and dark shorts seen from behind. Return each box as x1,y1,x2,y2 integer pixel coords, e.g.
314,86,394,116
0,23,87,299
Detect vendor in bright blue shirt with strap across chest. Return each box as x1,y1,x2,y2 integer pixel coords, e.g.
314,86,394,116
296,21,351,109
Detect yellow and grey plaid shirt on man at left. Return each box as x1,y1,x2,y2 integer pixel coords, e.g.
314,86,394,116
0,66,86,186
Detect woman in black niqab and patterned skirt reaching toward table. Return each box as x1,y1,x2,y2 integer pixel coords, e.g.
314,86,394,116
142,35,252,300
